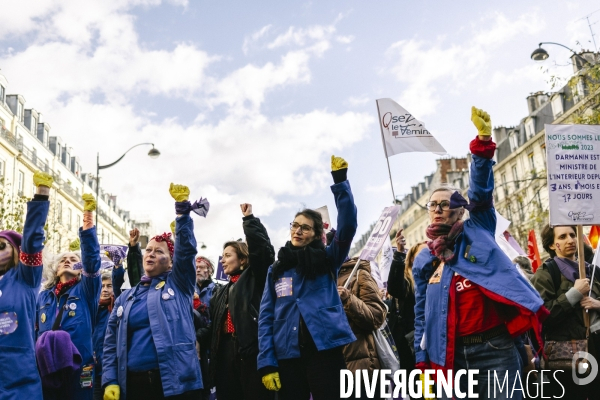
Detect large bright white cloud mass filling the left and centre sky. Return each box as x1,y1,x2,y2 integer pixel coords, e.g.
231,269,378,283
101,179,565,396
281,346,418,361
0,0,374,255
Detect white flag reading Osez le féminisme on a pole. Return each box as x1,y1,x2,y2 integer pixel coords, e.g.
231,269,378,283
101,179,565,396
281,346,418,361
377,99,447,158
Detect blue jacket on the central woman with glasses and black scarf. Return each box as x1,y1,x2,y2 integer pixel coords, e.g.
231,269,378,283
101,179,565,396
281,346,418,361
258,181,357,369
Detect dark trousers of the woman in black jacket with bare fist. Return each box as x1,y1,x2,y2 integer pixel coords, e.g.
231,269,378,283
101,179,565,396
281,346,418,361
211,334,275,400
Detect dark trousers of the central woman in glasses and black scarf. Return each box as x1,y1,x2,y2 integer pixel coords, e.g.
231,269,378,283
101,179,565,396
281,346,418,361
278,345,346,400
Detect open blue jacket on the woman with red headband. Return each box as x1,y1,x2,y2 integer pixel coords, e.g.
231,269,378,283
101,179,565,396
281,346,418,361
102,215,202,400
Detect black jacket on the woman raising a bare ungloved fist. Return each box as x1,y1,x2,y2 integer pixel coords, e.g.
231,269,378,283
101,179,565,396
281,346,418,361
209,215,275,383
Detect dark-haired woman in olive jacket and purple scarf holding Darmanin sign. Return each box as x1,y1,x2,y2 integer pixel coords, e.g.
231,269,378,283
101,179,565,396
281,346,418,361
532,225,600,400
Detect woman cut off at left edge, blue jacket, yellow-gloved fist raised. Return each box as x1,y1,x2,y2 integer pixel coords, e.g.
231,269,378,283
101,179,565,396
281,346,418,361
0,172,52,400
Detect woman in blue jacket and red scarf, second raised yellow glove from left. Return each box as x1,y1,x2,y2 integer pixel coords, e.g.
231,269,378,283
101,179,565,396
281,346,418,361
36,194,101,400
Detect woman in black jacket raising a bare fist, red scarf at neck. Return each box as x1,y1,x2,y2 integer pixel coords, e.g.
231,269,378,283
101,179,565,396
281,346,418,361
209,203,275,400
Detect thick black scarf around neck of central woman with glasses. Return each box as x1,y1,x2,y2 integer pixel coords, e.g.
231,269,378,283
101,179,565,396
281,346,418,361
273,239,331,281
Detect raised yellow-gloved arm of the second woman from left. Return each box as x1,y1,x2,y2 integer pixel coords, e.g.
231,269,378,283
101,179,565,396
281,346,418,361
79,194,102,322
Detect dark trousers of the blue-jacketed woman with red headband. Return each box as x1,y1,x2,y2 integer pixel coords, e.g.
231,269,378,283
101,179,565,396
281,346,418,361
127,370,201,400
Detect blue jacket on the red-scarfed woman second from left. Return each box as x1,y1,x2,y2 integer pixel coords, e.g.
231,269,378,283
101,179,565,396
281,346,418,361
37,227,102,399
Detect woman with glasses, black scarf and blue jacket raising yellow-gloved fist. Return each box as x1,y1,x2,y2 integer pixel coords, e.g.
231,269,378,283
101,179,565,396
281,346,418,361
258,156,357,400
